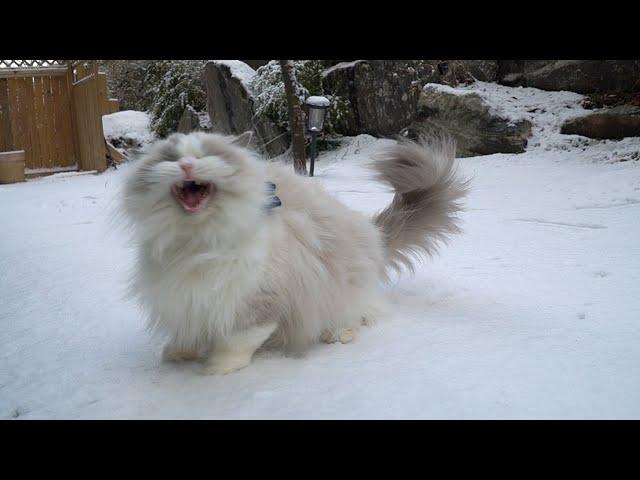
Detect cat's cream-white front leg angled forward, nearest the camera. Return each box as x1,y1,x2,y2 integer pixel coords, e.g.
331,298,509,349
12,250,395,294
202,322,278,375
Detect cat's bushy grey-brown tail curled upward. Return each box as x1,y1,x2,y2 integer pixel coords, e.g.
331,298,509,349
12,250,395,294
373,135,468,270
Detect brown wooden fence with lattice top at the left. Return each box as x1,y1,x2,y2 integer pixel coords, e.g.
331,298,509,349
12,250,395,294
0,61,118,173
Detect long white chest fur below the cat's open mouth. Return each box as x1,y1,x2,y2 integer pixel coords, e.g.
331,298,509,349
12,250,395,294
134,220,269,352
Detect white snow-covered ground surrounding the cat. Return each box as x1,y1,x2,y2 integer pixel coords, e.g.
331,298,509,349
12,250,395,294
0,84,640,419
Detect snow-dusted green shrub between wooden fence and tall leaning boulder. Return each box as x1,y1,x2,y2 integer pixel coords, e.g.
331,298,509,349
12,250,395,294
144,60,207,137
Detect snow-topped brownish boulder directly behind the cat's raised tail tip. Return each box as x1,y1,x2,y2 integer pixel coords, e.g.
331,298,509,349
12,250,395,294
407,85,531,157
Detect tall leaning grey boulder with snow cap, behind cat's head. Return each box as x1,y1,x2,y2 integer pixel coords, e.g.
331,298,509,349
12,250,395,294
203,61,289,156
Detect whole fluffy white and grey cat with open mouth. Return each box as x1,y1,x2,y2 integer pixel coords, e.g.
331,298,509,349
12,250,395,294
123,133,466,373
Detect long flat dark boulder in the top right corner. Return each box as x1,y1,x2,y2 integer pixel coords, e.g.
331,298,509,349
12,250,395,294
499,60,640,94
